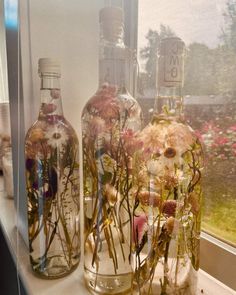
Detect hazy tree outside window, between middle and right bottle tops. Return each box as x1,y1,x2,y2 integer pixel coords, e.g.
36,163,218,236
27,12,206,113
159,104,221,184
140,24,176,88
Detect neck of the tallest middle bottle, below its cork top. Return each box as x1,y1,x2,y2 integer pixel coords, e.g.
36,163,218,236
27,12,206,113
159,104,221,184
99,22,131,88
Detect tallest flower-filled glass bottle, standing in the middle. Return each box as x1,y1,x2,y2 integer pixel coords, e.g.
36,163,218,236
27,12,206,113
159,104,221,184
82,7,141,294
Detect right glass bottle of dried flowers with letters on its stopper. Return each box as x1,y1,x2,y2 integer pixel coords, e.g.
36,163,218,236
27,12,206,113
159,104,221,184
132,37,203,295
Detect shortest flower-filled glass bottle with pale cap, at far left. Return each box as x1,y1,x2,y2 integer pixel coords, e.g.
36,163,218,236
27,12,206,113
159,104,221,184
25,58,80,279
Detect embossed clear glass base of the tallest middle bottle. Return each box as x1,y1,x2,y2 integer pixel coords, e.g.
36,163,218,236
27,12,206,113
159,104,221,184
84,267,132,295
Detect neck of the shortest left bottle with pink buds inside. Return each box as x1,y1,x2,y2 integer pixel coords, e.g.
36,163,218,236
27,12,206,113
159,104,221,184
39,74,63,118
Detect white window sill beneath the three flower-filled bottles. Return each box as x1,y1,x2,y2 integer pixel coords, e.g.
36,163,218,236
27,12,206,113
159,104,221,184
0,179,236,295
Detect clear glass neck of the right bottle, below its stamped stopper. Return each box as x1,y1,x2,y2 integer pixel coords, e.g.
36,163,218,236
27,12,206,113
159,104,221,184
154,86,184,120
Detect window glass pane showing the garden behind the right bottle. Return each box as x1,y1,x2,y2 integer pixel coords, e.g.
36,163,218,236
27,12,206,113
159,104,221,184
138,0,236,245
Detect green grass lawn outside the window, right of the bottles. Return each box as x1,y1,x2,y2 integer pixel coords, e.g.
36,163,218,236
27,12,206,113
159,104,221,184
202,162,236,247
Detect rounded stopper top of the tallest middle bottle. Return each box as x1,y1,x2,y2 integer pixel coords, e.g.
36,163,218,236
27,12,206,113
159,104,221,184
99,6,124,23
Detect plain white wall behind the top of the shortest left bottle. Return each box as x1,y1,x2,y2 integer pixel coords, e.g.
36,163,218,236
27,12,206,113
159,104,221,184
21,0,104,132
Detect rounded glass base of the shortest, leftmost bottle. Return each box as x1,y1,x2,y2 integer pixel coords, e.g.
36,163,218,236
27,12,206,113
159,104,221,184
31,255,80,280
